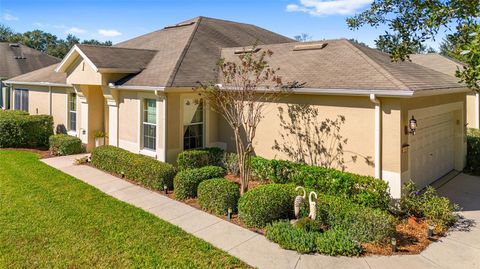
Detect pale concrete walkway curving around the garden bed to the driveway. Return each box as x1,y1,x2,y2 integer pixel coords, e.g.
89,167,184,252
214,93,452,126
42,155,480,269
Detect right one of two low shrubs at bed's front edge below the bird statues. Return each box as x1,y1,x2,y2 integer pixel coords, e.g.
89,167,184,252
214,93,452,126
315,229,363,256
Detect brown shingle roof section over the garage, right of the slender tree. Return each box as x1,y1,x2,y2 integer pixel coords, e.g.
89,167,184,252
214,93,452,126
222,39,462,91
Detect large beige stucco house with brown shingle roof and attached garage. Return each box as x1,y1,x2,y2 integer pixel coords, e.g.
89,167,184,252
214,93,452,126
3,17,468,198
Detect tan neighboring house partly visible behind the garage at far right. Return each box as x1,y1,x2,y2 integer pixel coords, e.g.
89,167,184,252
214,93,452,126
410,53,480,129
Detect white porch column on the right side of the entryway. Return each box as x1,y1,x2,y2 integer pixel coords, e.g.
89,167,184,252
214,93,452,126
102,86,119,147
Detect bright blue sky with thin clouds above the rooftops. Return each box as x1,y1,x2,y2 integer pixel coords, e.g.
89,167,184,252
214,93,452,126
0,0,448,47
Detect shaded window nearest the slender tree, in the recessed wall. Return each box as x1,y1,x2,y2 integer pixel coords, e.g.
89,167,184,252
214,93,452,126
183,98,204,150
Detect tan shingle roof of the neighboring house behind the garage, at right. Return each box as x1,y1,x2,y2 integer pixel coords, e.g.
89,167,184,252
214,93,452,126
410,53,464,76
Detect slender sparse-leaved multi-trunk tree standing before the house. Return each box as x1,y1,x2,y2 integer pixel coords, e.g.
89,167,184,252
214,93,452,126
199,46,294,194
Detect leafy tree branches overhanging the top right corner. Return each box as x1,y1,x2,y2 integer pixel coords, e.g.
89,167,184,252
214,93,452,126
347,0,480,91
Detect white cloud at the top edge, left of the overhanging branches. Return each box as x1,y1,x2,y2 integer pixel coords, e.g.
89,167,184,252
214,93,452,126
286,0,373,16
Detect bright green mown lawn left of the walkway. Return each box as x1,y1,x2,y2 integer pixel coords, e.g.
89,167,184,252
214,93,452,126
0,150,247,268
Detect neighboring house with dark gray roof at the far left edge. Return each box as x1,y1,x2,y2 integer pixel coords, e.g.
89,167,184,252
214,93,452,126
0,42,60,108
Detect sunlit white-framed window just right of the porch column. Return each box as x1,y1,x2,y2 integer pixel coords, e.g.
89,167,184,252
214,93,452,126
142,99,157,150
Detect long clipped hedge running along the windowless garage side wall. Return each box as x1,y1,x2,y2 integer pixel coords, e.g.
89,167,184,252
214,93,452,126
250,157,391,209
